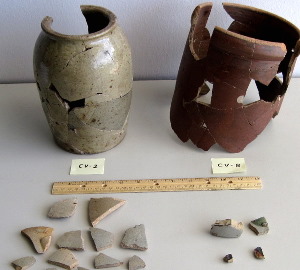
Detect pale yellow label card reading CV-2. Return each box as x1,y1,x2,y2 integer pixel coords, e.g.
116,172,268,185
70,158,105,174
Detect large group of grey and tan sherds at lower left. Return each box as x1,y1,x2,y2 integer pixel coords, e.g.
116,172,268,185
12,197,148,270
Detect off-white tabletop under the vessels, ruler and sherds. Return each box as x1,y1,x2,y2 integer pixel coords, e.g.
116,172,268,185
0,79,300,270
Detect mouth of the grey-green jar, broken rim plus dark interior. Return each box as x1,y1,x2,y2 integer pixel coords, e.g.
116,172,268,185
41,5,116,40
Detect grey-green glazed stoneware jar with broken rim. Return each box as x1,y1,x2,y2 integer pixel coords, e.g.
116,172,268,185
33,6,132,154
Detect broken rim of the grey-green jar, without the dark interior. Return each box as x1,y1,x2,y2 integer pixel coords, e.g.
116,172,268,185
41,5,117,40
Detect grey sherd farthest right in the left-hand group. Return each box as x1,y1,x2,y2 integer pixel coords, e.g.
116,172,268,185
121,224,148,250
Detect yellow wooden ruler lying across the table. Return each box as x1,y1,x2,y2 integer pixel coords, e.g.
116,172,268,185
52,176,262,195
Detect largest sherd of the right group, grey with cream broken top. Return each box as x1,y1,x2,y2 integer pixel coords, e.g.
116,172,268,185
210,219,244,238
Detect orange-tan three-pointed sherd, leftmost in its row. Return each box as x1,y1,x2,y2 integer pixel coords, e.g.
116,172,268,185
21,226,53,253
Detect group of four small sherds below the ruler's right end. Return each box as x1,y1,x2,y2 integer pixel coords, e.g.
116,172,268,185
210,217,269,263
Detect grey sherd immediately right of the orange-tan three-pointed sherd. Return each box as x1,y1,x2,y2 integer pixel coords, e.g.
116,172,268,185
56,231,84,251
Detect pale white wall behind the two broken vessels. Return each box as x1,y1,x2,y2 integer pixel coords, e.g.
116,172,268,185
0,0,300,83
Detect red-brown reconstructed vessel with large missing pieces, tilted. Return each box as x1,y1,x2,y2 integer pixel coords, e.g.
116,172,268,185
170,3,300,153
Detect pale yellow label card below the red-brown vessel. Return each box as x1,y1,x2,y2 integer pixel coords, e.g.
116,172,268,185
211,158,247,174
